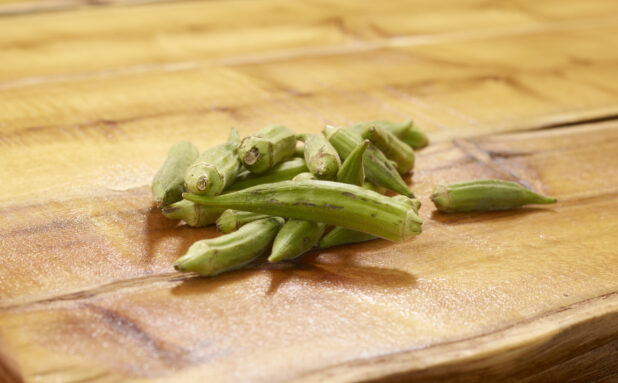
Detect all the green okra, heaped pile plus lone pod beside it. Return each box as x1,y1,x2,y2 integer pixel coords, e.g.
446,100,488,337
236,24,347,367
152,121,556,276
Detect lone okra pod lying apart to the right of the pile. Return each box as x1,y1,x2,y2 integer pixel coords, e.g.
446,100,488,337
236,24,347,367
431,180,556,213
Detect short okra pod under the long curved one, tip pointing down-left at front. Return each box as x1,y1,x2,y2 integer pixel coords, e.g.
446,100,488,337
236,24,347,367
268,219,326,262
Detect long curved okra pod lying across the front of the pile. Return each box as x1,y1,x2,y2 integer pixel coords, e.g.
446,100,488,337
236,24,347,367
183,181,422,241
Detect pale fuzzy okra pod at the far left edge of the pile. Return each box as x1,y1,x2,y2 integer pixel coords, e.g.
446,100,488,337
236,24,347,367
152,141,200,207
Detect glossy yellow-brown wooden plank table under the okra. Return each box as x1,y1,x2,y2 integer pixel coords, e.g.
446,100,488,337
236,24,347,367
0,0,618,383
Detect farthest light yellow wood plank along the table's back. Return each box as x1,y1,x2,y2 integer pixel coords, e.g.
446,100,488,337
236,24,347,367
0,0,618,81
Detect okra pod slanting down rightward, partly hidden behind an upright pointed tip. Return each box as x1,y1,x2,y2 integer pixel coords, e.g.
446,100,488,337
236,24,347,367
324,125,414,197
